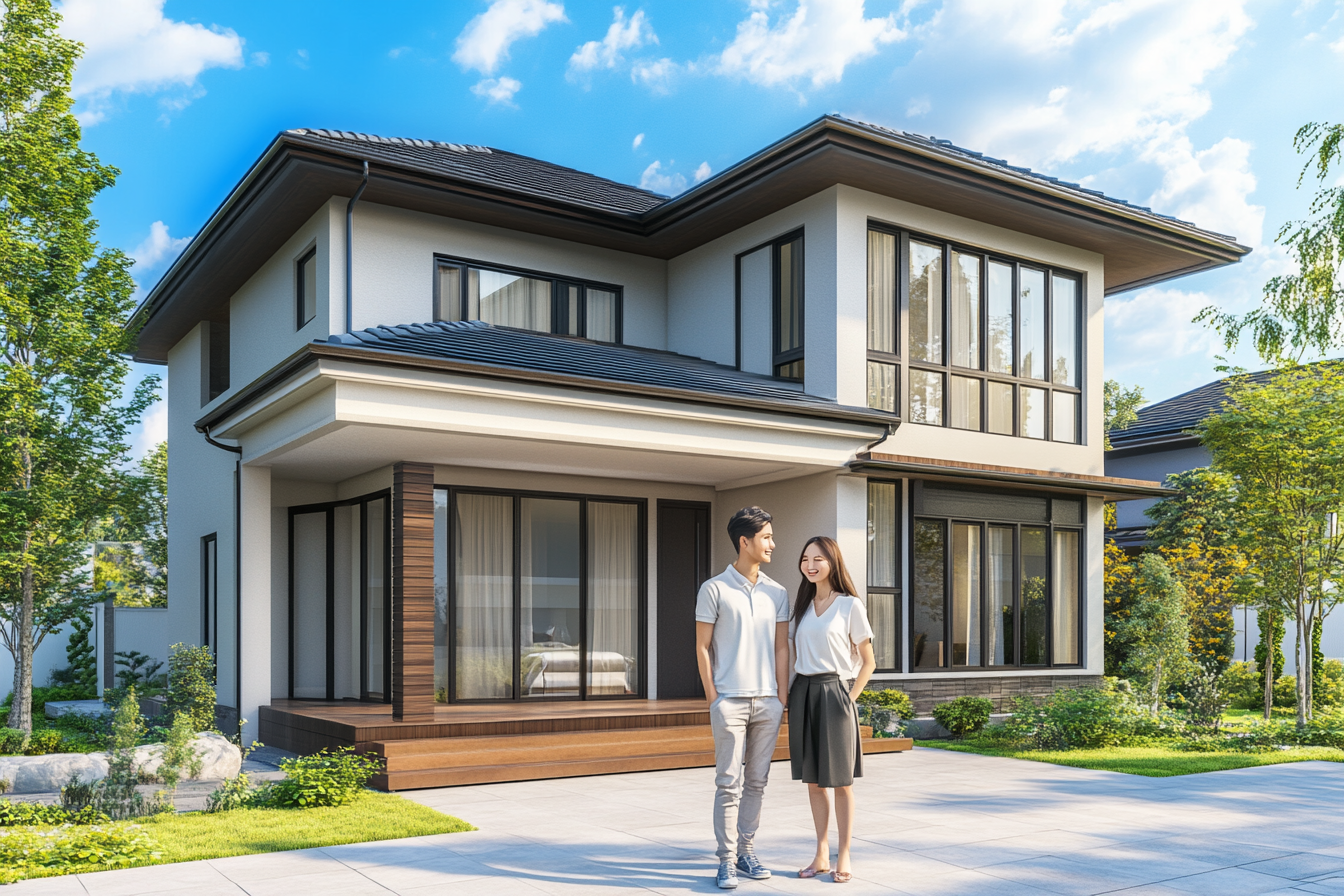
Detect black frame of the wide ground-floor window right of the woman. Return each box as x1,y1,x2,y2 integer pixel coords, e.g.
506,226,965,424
906,480,1087,674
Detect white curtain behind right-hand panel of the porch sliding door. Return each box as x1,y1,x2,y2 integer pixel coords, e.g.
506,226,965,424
587,501,640,695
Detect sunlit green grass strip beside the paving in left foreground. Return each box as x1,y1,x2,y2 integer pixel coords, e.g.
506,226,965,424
17,790,476,877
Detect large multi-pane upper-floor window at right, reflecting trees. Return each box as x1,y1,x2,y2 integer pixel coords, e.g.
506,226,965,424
868,227,1082,442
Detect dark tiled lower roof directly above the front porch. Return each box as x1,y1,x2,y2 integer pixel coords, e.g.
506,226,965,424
198,321,900,430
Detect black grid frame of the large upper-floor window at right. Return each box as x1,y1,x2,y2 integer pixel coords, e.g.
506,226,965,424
864,220,1087,445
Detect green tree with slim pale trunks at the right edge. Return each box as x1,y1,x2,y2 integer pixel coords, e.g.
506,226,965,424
1198,361,1344,725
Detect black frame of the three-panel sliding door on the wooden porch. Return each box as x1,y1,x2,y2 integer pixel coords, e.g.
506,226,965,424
434,485,649,705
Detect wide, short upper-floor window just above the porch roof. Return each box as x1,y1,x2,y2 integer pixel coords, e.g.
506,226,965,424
434,259,621,343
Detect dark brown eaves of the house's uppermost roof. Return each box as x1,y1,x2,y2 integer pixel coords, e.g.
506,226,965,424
130,116,1250,363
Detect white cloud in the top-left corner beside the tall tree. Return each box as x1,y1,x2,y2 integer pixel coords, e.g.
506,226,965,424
60,0,243,125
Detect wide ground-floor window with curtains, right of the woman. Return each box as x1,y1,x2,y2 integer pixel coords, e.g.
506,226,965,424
910,484,1082,672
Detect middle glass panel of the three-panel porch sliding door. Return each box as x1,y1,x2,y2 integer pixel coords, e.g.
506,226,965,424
519,498,582,697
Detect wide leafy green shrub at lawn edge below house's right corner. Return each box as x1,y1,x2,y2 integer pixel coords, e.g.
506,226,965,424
1004,678,1148,750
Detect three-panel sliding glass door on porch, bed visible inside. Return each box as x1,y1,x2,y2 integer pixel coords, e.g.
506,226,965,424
446,490,645,703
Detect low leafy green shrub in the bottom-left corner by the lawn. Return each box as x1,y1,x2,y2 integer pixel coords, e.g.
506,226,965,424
0,825,159,883
